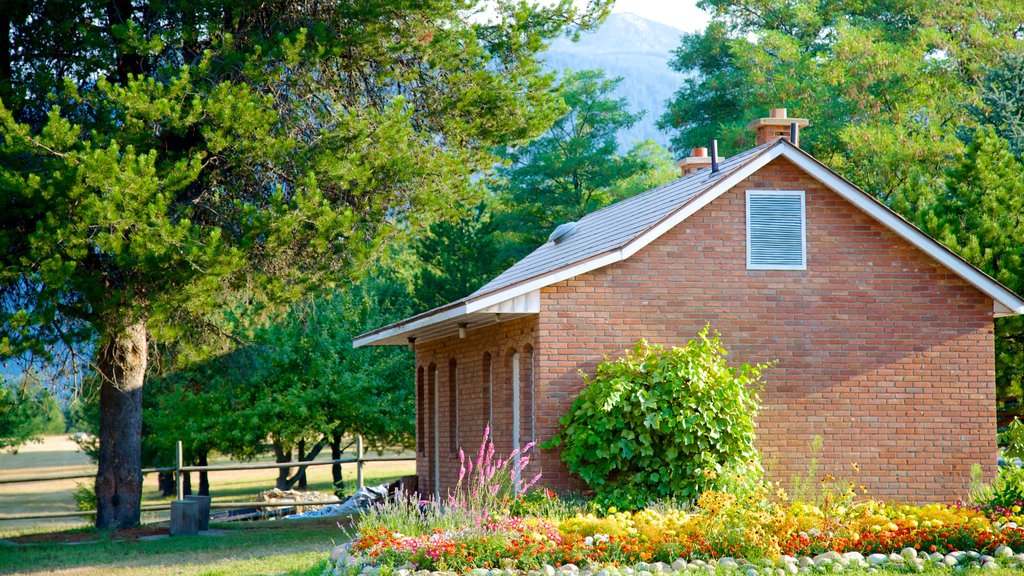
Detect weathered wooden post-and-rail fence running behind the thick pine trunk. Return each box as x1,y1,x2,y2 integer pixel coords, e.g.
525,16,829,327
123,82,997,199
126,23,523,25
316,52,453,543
0,436,416,522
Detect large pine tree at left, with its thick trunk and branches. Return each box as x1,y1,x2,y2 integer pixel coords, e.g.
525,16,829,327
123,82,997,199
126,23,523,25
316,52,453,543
0,0,607,528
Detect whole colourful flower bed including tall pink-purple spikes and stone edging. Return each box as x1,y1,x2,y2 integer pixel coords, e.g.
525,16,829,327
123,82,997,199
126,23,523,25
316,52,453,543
331,424,1024,576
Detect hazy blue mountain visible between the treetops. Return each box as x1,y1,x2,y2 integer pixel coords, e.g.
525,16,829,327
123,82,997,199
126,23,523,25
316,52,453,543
546,12,684,150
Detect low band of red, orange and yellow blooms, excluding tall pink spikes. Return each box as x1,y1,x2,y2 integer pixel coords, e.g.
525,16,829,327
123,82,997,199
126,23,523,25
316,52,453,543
337,493,1024,573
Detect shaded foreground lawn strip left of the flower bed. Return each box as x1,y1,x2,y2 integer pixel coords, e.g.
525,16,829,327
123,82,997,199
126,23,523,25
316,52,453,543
0,519,346,576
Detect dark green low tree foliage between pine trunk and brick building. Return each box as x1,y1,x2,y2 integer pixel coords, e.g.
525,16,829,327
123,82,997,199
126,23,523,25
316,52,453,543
144,266,415,462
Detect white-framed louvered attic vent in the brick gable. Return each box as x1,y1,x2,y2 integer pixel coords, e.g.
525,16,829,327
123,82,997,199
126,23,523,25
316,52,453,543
746,190,807,270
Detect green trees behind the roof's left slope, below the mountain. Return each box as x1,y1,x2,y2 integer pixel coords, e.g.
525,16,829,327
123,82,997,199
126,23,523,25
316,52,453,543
414,71,678,310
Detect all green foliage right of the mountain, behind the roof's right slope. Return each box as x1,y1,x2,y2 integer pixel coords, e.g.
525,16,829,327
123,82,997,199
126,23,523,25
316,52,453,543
659,0,1024,398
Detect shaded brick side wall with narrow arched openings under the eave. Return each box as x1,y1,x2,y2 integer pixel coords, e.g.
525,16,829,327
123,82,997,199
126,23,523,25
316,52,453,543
416,317,537,495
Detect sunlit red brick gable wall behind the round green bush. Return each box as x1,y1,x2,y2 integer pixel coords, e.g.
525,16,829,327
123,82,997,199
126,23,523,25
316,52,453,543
535,159,995,501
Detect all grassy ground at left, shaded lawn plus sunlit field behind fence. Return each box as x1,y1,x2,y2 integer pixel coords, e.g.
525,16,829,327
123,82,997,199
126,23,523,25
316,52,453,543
0,437,416,576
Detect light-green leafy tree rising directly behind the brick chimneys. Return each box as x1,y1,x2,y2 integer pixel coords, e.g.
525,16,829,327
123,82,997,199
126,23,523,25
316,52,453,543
660,0,1024,203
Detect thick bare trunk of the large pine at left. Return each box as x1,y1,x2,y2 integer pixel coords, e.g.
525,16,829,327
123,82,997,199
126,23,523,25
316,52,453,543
96,321,147,530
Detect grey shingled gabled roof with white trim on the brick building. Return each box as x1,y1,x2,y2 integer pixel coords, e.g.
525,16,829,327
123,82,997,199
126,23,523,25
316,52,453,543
353,138,1024,347
